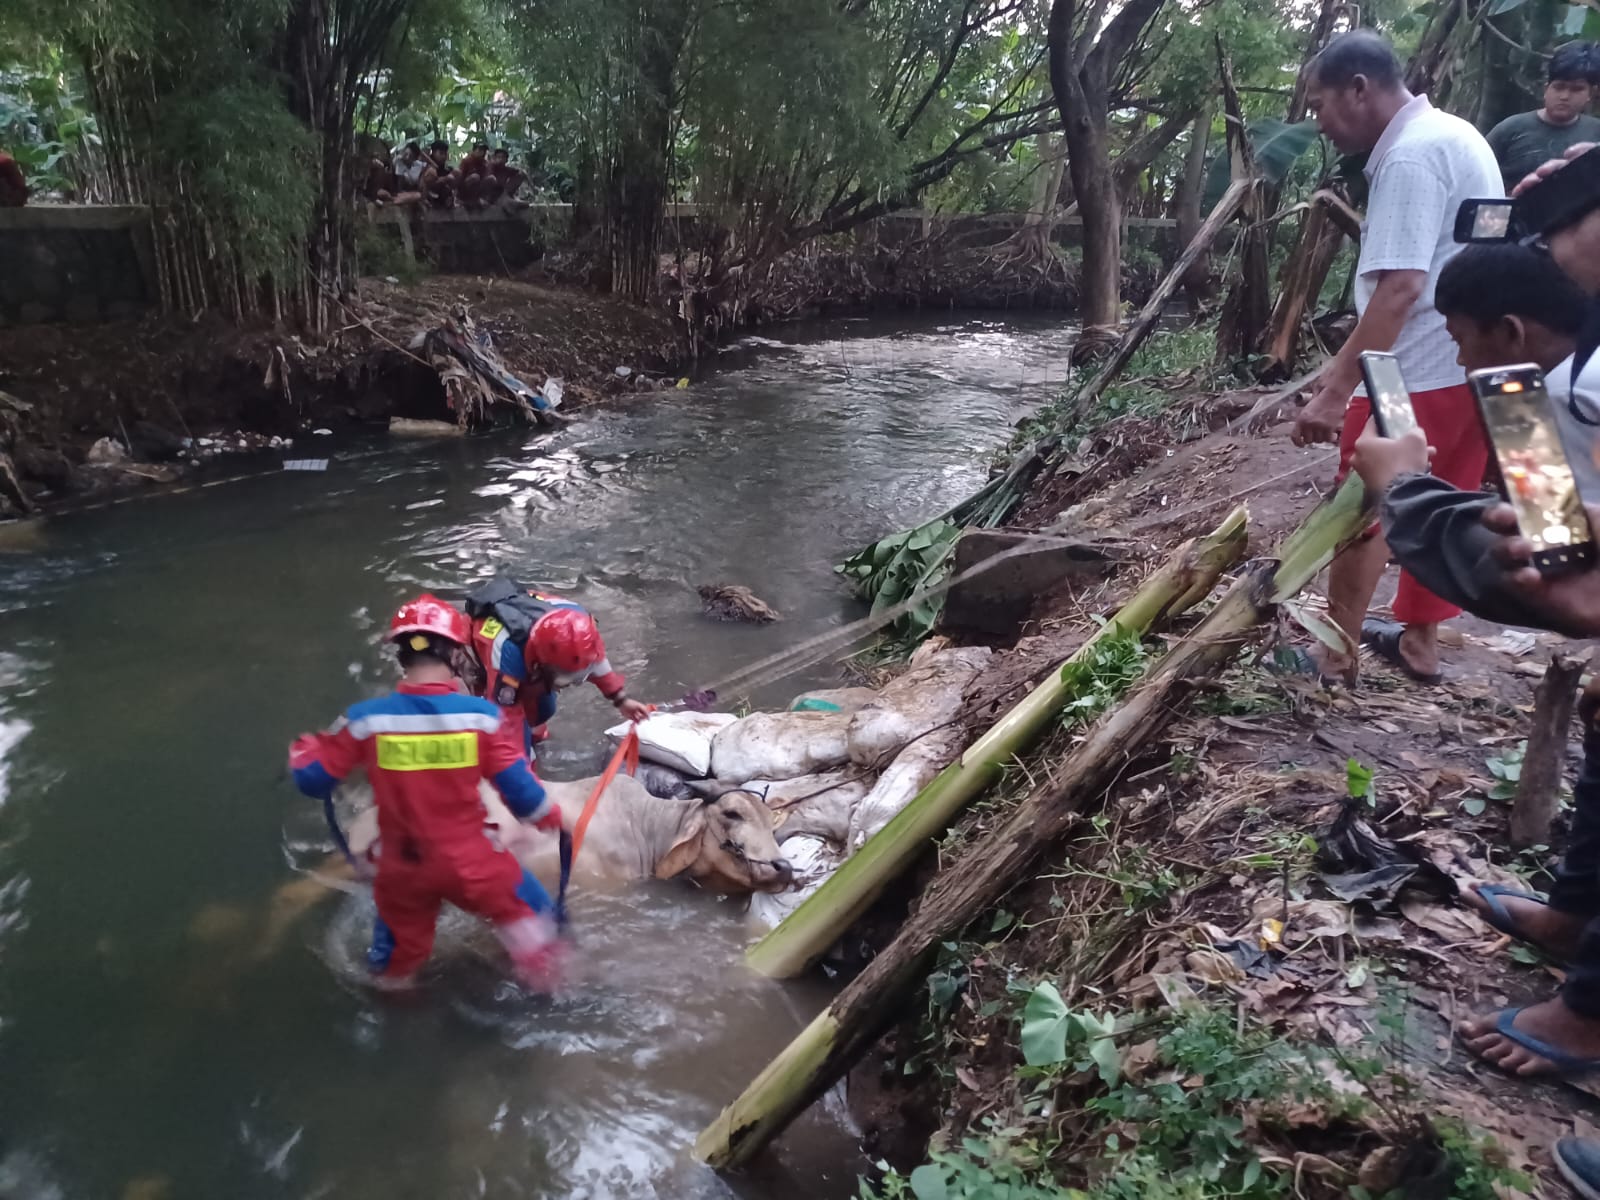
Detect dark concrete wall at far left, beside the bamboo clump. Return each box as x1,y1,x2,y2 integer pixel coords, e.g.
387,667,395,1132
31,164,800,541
0,205,160,325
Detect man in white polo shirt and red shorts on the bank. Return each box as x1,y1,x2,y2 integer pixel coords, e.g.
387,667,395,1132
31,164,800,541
1294,29,1504,683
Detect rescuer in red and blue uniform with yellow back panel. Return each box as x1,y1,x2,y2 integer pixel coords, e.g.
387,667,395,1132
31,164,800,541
290,595,562,990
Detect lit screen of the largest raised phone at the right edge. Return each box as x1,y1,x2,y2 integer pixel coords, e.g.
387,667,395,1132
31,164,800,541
1472,366,1594,554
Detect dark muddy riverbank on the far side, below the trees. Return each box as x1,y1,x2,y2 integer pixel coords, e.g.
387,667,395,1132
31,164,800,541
0,230,1177,518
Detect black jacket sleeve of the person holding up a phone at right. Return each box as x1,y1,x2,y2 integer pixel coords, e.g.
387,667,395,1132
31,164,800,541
1379,474,1531,626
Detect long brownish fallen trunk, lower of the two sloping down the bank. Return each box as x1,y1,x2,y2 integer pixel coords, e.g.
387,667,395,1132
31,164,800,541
694,477,1370,1170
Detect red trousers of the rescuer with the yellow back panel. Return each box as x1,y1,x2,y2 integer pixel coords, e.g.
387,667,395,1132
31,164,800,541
368,837,542,978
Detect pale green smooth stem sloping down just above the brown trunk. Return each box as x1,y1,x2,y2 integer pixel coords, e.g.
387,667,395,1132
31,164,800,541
747,507,1248,979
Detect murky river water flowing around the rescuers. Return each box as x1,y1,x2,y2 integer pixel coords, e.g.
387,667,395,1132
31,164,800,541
0,317,1070,1200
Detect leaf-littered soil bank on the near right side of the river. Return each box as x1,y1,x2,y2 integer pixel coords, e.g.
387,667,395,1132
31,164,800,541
851,382,1600,1200
